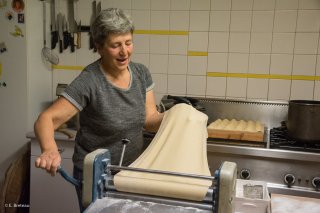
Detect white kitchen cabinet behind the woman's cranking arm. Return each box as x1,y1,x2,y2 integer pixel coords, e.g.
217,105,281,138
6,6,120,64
27,133,79,213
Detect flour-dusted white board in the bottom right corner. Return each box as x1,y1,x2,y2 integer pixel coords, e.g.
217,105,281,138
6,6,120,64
271,194,320,213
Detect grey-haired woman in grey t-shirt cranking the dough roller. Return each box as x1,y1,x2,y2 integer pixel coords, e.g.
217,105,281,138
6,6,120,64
35,8,163,211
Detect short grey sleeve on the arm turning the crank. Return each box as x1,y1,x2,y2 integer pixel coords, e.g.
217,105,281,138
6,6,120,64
61,70,92,111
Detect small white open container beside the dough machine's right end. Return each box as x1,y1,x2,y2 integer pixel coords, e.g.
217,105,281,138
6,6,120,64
234,179,271,213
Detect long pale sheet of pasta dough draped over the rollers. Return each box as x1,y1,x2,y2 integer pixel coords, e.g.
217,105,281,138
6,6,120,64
114,104,212,201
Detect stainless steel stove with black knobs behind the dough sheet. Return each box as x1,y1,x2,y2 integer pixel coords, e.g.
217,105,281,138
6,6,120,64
160,96,320,198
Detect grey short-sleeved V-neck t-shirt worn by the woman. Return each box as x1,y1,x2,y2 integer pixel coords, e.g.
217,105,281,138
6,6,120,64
62,60,154,169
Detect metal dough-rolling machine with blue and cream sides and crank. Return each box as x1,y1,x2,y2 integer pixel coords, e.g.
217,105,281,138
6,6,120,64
58,149,237,213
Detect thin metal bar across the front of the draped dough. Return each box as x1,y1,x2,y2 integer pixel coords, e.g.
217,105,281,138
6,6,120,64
107,165,216,181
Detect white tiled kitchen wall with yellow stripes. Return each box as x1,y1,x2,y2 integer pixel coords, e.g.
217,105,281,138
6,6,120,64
53,0,320,101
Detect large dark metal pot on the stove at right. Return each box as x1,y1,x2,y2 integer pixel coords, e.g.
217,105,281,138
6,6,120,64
287,100,320,142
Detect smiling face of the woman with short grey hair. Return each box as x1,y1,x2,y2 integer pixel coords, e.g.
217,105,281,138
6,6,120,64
98,32,133,71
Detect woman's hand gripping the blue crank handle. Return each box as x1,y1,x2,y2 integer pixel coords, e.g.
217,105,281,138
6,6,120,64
35,150,61,176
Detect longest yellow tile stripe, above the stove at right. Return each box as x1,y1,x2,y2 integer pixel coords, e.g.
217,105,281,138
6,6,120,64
207,72,320,81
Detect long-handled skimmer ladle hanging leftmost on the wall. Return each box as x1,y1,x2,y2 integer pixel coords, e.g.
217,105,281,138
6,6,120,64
41,1,59,65
